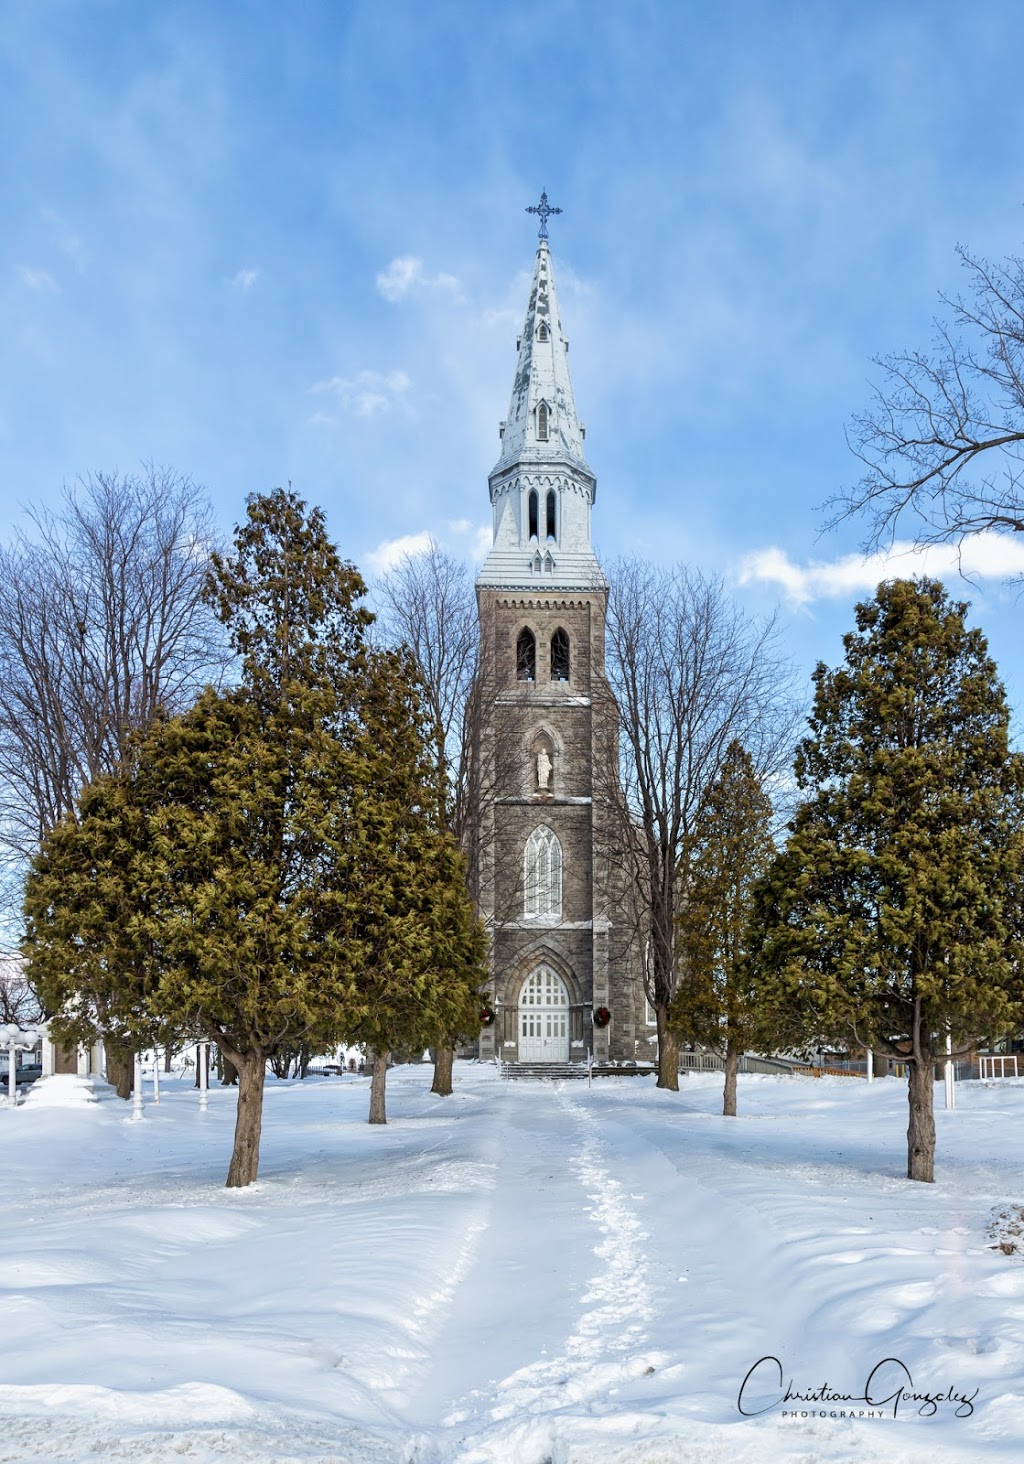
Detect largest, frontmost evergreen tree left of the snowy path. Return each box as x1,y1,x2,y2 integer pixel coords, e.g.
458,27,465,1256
26,490,372,1186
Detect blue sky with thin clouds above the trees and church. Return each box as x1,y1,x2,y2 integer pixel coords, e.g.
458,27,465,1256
0,0,1024,712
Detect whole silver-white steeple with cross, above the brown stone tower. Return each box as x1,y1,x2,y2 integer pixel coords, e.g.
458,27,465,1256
478,218,604,589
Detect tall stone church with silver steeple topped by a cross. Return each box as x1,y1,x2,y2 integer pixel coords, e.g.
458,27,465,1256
472,195,656,1064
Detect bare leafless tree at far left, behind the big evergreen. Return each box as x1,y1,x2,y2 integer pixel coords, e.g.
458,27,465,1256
0,467,226,890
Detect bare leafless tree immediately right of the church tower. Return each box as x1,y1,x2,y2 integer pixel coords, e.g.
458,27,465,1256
595,559,797,1089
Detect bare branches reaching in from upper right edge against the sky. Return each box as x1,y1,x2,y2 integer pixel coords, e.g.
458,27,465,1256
829,247,1024,562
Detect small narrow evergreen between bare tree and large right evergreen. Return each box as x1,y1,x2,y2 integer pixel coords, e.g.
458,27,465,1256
669,741,785,1117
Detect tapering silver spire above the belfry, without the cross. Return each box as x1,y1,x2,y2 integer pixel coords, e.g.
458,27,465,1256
495,239,586,471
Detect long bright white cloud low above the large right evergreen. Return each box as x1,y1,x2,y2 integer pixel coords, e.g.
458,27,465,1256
737,531,1024,606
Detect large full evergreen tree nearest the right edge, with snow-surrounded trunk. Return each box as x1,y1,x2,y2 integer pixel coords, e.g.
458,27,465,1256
752,580,1024,1181
